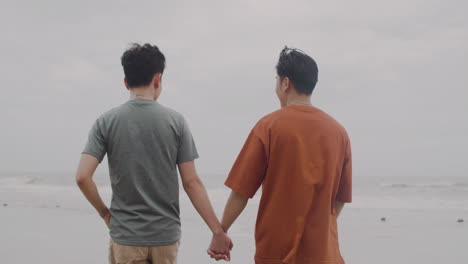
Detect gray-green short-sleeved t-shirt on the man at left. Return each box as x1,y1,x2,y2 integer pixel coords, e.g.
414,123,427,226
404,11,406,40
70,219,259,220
83,99,198,246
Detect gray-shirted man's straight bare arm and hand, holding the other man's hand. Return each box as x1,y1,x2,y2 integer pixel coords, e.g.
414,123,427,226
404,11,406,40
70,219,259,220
179,161,232,260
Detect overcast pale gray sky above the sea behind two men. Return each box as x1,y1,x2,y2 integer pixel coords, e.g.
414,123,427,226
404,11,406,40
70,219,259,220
0,0,468,176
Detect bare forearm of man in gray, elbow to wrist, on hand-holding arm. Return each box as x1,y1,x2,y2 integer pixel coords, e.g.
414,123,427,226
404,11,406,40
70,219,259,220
185,181,223,234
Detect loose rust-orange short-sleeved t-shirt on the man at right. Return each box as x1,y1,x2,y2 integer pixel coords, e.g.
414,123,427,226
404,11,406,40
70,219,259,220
225,105,351,264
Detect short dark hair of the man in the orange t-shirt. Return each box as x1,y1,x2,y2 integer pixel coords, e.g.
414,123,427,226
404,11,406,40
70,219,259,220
276,46,318,95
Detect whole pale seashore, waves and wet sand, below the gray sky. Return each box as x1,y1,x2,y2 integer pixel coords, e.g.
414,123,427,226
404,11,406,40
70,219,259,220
0,173,468,264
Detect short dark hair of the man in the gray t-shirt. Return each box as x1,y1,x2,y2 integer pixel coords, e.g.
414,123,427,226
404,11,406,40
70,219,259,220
121,43,166,87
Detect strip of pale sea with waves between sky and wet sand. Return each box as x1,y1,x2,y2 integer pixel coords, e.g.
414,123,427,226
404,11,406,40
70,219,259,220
0,172,468,210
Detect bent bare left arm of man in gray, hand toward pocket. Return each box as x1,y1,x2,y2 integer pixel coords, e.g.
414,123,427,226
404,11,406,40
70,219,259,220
76,154,110,226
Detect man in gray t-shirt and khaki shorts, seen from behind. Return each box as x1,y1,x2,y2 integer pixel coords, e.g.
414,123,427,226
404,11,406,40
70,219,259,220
76,44,232,263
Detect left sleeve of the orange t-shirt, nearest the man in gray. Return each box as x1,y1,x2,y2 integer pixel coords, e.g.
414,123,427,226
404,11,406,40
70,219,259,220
225,131,268,198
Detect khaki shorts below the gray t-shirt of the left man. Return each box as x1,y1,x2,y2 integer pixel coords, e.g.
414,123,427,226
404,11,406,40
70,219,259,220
109,239,180,264
